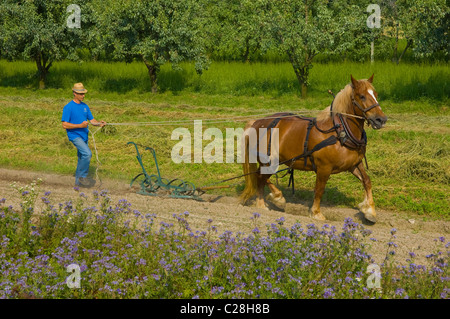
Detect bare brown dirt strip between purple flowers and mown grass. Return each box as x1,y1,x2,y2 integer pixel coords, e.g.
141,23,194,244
0,168,450,264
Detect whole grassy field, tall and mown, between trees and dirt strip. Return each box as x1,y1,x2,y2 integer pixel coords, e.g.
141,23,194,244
0,61,450,220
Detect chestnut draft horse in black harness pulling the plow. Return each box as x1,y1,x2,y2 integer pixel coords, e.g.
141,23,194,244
240,74,388,223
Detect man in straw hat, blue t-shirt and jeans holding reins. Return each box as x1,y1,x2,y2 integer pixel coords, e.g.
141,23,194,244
61,83,106,187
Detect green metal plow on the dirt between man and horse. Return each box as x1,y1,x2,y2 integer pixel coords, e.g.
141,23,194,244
127,142,204,201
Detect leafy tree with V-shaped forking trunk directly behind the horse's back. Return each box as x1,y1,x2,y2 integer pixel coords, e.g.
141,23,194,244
267,0,365,97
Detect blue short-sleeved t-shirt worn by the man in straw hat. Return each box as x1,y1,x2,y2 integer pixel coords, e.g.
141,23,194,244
61,100,94,142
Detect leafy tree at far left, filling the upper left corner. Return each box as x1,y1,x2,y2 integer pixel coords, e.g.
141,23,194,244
0,0,83,88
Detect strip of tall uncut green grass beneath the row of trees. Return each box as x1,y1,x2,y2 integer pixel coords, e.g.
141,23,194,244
0,60,450,105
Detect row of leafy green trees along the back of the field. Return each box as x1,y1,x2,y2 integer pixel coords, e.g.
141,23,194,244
0,0,450,96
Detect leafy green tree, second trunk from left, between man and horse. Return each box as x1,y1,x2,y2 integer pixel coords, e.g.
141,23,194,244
94,0,207,93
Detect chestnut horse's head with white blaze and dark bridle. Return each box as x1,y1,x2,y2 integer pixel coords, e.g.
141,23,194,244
351,74,387,130
